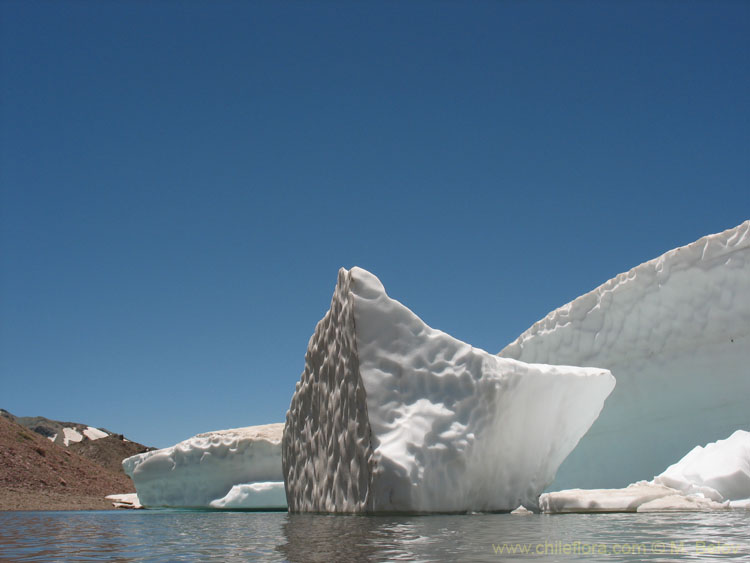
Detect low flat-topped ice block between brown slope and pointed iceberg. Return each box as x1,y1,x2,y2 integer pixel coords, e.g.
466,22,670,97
122,424,286,509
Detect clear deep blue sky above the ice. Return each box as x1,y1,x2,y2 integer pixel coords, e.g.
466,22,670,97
0,0,750,447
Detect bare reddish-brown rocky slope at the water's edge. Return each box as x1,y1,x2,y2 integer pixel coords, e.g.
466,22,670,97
0,417,135,510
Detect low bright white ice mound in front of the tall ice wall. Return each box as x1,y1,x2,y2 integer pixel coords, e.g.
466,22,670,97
539,430,750,514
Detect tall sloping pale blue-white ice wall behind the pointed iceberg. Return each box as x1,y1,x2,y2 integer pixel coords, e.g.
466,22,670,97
500,221,750,489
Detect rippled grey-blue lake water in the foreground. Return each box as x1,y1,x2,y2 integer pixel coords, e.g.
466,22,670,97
0,510,750,563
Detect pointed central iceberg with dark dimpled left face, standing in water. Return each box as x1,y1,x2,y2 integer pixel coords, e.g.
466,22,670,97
282,268,615,512
